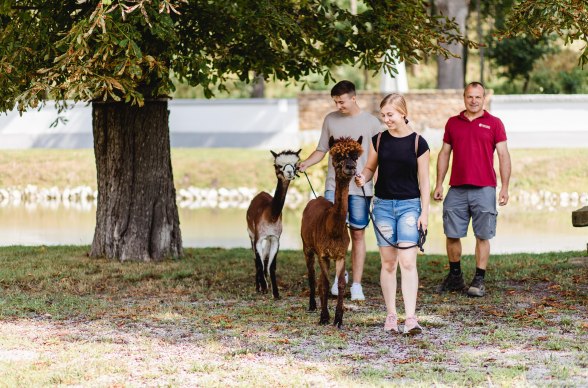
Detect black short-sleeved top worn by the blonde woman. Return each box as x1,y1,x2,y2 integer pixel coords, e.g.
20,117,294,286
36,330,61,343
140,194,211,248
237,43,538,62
372,131,429,199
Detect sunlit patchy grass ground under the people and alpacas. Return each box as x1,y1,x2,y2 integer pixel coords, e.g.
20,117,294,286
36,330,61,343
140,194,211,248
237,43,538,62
0,246,588,387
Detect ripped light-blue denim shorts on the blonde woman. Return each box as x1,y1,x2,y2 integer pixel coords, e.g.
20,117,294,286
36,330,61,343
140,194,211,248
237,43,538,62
373,197,421,247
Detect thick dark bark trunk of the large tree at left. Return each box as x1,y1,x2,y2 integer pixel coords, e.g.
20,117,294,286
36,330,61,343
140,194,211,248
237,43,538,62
90,100,182,261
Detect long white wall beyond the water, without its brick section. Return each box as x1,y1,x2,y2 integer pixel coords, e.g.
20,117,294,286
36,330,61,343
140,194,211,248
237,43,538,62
0,95,588,149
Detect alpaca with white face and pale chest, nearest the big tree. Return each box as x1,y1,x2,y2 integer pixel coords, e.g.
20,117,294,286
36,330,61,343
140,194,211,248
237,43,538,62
247,150,301,299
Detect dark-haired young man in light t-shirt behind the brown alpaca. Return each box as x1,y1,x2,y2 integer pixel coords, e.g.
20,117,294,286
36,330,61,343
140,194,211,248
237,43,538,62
299,81,382,300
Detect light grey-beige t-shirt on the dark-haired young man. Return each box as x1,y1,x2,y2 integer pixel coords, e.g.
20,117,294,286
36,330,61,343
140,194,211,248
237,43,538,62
316,111,382,196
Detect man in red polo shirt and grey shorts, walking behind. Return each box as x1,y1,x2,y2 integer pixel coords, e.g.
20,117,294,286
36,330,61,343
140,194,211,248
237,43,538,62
433,82,511,297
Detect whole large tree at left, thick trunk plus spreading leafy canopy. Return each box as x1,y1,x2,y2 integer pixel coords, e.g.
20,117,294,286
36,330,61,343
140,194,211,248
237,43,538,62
0,0,464,261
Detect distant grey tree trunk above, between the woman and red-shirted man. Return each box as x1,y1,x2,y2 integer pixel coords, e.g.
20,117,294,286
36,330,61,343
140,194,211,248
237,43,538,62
435,0,469,89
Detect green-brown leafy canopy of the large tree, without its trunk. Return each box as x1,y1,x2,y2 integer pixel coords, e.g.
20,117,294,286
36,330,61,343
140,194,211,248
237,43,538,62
0,0,476,111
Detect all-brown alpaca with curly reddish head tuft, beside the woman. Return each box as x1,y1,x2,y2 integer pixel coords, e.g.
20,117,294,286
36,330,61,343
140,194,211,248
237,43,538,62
301,136,363,327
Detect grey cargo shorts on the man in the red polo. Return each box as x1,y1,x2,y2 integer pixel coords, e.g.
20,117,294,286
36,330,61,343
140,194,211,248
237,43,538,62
443,186,498,240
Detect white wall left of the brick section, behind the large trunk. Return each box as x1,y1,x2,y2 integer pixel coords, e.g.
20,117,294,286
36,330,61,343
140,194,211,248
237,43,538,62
0,99,300,149
